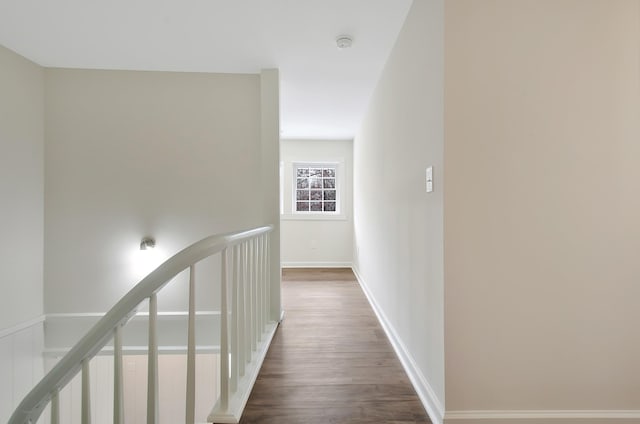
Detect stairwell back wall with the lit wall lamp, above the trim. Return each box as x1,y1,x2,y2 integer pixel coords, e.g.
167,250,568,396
45,69,278,313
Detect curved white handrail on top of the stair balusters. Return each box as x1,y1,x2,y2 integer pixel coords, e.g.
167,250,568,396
8,225,273,424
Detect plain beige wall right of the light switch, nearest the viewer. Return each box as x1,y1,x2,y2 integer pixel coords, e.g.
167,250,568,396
444,0,640,423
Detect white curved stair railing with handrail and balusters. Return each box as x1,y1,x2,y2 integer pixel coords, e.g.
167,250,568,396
8,226,277,424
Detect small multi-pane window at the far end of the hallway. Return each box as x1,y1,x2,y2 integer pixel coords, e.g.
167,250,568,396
293,163,340,214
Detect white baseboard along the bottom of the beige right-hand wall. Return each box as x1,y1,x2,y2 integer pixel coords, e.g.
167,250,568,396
444,410,640,424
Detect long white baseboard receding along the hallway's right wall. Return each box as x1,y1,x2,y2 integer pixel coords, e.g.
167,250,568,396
352,267,448,424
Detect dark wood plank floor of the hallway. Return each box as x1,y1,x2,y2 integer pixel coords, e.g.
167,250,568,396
240,269,430,424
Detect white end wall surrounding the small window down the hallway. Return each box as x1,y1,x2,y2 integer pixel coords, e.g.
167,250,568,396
280,140,353,267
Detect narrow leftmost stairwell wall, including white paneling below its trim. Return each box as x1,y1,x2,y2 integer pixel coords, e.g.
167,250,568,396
0,46,44,422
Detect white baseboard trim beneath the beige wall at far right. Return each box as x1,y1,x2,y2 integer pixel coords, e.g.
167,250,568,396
445,410,640,423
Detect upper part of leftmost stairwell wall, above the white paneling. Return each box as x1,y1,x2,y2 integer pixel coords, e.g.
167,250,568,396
0,46,44,330
